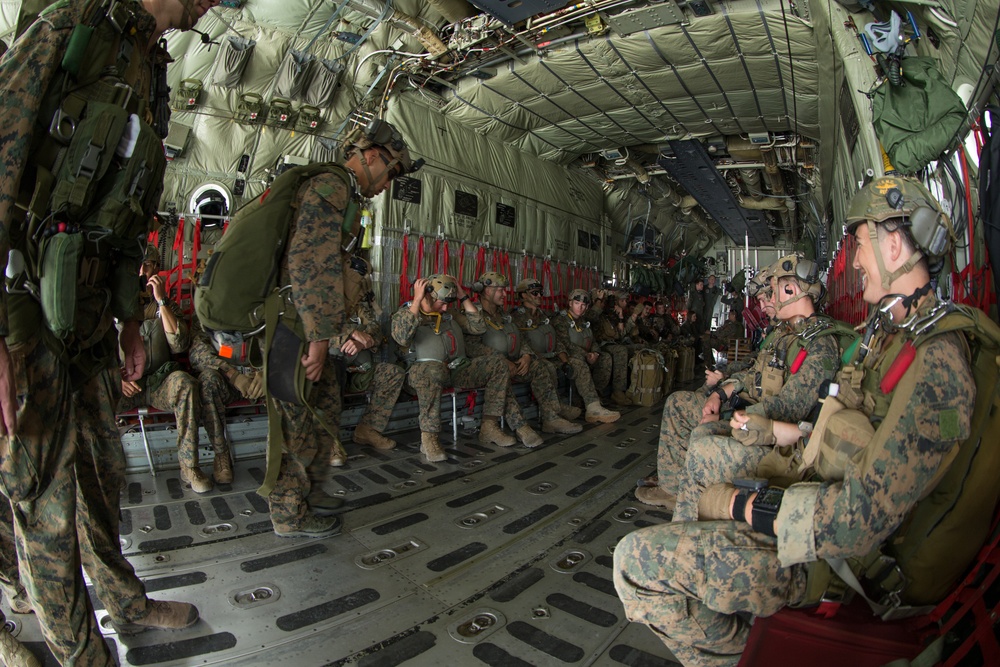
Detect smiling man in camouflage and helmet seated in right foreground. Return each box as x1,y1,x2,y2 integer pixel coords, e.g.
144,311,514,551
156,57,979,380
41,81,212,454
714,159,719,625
614,178,976,667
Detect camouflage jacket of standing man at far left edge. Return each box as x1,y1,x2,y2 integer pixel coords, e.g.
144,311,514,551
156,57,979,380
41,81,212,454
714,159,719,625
0,0,164,336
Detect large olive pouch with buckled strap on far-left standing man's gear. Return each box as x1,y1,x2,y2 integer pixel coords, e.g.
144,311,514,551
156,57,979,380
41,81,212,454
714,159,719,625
50,101,131,222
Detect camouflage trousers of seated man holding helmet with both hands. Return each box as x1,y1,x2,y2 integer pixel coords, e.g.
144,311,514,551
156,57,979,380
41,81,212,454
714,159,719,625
409,354,527,433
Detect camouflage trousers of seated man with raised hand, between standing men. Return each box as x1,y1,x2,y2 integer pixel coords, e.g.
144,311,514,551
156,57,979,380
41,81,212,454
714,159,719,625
118,371,226,468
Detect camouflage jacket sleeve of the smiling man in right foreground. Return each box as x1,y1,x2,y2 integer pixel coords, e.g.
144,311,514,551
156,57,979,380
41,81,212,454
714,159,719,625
775,295,976,567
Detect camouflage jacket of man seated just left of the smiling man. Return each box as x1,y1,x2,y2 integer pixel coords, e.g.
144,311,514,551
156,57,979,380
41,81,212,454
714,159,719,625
723,315,840,424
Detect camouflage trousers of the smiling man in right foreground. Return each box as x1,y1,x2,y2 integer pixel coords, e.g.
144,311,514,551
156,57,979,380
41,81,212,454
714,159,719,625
614,521,806,667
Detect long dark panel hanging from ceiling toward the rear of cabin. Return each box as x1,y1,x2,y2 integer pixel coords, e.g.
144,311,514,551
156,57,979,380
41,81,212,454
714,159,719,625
658,139,774,246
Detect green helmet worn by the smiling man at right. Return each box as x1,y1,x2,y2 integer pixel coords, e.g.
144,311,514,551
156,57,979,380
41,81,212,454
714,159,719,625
847,176,954,258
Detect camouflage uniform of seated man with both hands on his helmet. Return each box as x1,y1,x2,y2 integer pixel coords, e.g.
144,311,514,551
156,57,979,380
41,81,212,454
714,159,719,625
392,303,527,433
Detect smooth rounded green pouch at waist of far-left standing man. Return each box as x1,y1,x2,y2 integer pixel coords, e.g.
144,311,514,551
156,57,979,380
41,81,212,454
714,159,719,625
39,233,83,340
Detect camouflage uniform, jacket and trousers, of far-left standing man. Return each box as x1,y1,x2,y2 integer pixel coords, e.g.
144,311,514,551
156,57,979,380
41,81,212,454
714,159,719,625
0,2,172,665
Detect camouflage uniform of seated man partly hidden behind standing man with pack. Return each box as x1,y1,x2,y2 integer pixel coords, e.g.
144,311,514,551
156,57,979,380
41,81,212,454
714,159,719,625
330,253,406,433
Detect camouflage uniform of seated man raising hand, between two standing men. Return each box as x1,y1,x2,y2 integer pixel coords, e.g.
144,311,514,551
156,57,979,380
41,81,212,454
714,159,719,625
118,302,228,468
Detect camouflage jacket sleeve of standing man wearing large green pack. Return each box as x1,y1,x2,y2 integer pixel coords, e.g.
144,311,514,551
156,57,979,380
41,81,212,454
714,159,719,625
279,173,350,347
